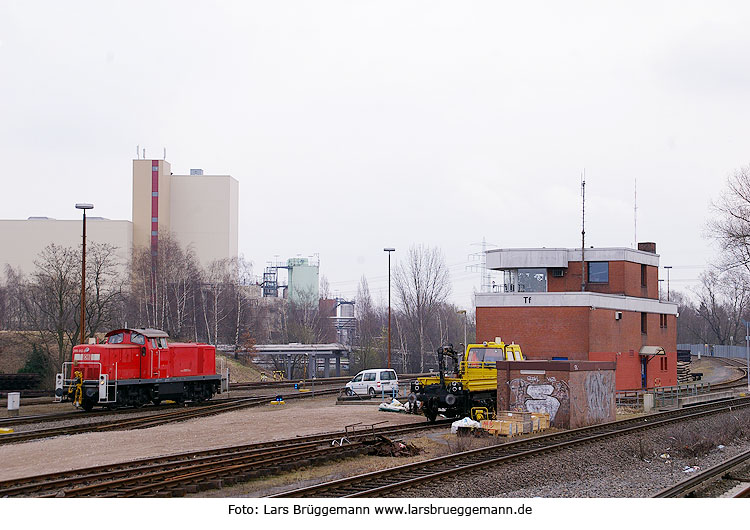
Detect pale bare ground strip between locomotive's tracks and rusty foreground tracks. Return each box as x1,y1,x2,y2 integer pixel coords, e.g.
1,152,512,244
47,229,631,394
0,396,425,480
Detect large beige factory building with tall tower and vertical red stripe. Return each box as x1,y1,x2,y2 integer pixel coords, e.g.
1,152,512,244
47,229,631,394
0,159,239,275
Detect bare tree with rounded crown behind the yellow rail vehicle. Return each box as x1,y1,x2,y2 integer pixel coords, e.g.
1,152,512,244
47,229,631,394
394,245,451,372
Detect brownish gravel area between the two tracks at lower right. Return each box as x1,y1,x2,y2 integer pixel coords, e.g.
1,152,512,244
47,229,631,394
393,410,750,498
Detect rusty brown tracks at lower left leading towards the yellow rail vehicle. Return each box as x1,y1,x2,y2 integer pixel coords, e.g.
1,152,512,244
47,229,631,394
0,422,450,497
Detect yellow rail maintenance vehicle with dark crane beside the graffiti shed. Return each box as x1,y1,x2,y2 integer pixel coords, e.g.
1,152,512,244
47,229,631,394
409,338,524,422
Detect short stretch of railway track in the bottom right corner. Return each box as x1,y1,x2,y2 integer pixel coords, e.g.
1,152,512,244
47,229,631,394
654,451,750,498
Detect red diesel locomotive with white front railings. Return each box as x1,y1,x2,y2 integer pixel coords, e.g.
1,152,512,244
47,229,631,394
55,329,221,411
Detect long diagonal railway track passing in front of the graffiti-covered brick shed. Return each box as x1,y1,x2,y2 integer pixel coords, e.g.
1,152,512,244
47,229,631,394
272,398,750,497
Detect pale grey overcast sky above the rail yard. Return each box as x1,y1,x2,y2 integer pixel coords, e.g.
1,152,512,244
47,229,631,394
0,0,750,307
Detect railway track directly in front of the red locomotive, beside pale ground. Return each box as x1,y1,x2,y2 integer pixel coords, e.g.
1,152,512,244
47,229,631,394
0,389,338,445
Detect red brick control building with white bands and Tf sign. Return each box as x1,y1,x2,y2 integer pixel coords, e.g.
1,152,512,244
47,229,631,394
476,243,677,390
